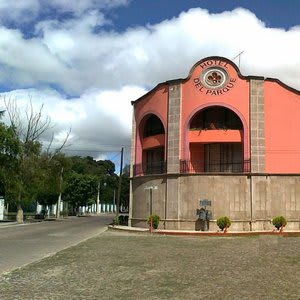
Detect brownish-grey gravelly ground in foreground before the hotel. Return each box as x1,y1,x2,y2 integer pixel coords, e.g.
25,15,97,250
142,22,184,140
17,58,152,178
0,231,300,300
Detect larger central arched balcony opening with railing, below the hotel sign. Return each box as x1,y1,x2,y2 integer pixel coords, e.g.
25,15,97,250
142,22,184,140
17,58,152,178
181,106,250,173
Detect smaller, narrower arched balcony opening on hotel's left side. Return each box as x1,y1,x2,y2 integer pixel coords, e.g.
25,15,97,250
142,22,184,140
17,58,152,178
135,114,166,175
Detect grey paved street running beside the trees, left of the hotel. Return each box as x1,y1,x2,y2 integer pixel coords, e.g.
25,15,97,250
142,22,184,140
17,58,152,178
0,215,113,274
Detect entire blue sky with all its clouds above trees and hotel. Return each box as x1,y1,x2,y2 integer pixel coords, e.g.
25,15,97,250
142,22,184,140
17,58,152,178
0,0,300,162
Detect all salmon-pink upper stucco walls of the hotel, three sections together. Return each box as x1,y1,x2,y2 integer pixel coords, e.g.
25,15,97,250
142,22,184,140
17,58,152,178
134,58,300,173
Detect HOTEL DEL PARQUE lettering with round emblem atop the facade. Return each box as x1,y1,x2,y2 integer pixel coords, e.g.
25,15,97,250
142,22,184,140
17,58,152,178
193,59,236,96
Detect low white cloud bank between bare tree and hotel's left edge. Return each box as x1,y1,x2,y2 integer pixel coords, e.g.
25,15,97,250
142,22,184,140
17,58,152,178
0,86,146,159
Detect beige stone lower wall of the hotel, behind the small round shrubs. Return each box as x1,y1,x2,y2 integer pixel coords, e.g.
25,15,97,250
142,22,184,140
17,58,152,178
131,174,300,231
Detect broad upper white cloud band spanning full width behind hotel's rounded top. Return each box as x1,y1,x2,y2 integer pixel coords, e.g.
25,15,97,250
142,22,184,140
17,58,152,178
0,6,300,95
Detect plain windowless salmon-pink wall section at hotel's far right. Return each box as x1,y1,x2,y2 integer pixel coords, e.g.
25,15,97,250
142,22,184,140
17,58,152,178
264,81,300,173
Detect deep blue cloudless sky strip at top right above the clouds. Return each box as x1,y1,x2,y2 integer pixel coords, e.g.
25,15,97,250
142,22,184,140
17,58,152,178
114,0,300,30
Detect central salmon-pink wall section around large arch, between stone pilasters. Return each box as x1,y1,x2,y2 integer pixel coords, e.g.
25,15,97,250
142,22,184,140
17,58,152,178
181,59,250,159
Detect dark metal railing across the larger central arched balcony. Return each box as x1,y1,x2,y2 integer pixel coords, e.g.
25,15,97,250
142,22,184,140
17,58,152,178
180,160,250,174
